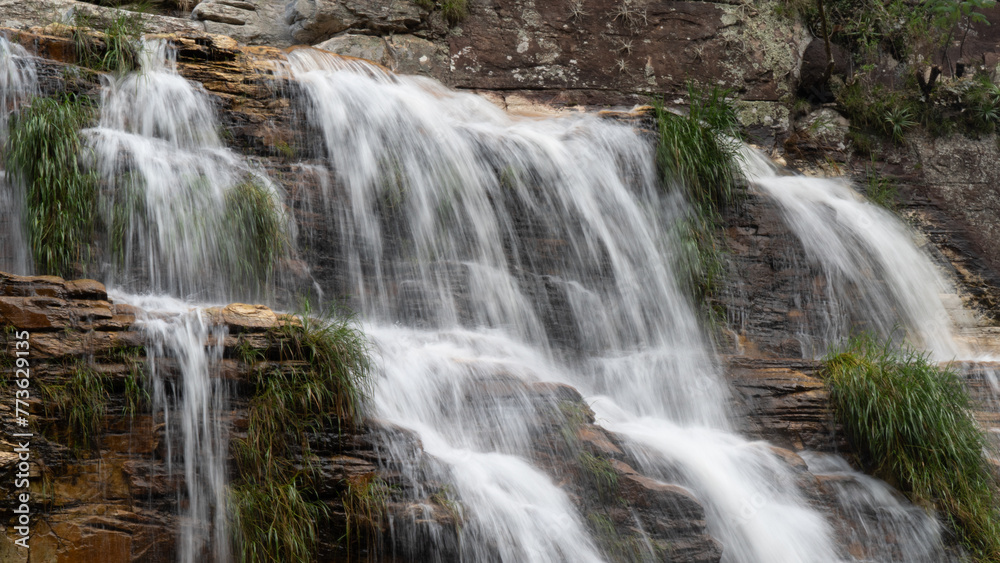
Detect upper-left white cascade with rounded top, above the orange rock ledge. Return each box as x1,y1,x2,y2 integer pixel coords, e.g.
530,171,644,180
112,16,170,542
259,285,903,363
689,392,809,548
87,41,287,301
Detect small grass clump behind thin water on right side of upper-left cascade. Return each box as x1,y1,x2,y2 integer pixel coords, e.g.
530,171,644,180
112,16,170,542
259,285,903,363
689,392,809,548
222,181,288,298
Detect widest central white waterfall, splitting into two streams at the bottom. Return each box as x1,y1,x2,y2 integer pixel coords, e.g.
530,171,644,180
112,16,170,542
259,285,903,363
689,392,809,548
289,50,852,563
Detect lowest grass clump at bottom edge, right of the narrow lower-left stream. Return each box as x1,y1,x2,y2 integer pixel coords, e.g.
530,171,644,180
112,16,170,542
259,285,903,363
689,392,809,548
229,478,329,563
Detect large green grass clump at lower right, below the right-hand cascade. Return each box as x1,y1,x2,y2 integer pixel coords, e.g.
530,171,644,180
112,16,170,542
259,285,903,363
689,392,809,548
826,334,1000,561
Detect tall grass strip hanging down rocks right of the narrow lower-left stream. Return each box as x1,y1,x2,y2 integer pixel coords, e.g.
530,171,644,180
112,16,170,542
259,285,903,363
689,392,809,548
230,304,376,562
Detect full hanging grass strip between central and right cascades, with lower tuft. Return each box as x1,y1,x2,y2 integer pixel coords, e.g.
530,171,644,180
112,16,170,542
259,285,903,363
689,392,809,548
654,84,745,312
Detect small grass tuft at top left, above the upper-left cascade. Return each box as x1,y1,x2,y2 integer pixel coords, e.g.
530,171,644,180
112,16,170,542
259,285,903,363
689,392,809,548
73,10,146,74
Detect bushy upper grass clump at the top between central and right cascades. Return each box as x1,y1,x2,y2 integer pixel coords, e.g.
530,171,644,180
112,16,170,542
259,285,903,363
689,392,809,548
655,83,742,216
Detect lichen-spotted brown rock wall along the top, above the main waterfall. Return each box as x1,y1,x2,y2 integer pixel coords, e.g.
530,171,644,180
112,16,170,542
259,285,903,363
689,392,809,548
0,0,809,112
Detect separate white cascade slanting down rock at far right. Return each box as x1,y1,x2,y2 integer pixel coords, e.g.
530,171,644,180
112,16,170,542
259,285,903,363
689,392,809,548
742,147,959,360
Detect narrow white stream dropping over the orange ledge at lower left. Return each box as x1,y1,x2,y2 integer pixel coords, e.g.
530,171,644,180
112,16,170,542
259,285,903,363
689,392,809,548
122,294,231,563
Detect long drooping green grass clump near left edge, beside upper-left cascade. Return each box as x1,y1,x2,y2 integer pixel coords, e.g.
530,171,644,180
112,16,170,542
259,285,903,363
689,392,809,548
4,96,97,277
